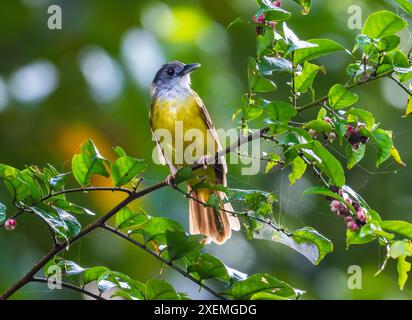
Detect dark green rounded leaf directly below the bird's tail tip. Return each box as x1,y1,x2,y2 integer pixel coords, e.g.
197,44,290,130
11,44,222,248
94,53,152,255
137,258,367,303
187,253,229,281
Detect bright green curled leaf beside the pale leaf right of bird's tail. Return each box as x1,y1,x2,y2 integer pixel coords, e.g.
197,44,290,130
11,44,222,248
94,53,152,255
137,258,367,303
293,227,333,265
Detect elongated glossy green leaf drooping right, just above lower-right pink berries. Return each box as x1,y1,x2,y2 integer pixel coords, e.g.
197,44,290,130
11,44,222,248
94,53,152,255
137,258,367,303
293,140,345,187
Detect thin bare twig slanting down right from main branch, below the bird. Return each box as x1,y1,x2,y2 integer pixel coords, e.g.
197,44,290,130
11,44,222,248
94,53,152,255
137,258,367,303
102,225,226,300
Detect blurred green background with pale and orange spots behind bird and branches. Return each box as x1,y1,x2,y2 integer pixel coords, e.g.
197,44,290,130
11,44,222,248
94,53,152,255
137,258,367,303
0,0,412,299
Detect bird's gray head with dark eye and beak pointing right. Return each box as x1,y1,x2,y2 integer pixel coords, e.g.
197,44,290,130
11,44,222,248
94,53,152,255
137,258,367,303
152,61,200,96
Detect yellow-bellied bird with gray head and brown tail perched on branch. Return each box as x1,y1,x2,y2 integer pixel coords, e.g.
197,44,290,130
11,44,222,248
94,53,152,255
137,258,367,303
149,61,240,245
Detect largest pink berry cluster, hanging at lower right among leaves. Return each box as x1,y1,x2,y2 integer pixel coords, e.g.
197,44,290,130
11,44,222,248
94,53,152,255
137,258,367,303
329,189,366,232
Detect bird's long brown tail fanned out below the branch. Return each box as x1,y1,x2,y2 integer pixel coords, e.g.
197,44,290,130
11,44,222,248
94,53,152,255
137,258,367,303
189,187,240,244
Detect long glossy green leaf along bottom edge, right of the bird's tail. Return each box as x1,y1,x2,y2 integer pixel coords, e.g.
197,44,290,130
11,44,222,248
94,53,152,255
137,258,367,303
225,273,299,300
